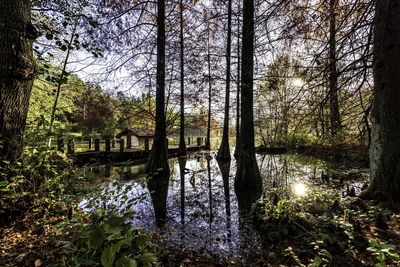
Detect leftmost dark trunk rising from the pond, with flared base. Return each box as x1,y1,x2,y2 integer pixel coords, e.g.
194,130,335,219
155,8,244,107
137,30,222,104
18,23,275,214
146,0,169,176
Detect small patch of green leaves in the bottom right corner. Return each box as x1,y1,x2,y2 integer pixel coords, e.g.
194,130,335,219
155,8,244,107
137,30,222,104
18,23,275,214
367,240,400,267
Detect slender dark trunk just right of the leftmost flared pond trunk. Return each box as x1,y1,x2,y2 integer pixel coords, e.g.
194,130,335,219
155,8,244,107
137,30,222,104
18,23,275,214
178,0,187,156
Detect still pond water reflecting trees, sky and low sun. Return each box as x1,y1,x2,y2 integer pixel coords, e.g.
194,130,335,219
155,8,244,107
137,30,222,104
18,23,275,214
80,153,368,264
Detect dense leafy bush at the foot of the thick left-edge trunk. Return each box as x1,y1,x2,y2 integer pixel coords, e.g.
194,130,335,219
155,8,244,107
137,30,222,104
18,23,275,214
0,147,86,223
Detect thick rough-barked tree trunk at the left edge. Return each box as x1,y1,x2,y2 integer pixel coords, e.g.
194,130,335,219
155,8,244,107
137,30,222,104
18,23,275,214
0,0,36,160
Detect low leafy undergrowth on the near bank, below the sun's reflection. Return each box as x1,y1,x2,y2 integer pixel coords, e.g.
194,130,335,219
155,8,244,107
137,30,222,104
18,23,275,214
253,189,353,266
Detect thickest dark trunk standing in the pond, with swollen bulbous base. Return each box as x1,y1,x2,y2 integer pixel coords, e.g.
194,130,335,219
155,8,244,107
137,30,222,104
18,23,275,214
235,0,262,201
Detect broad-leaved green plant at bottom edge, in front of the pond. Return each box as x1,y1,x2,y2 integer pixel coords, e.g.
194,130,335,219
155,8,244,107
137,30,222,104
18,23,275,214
67,214,157,267
